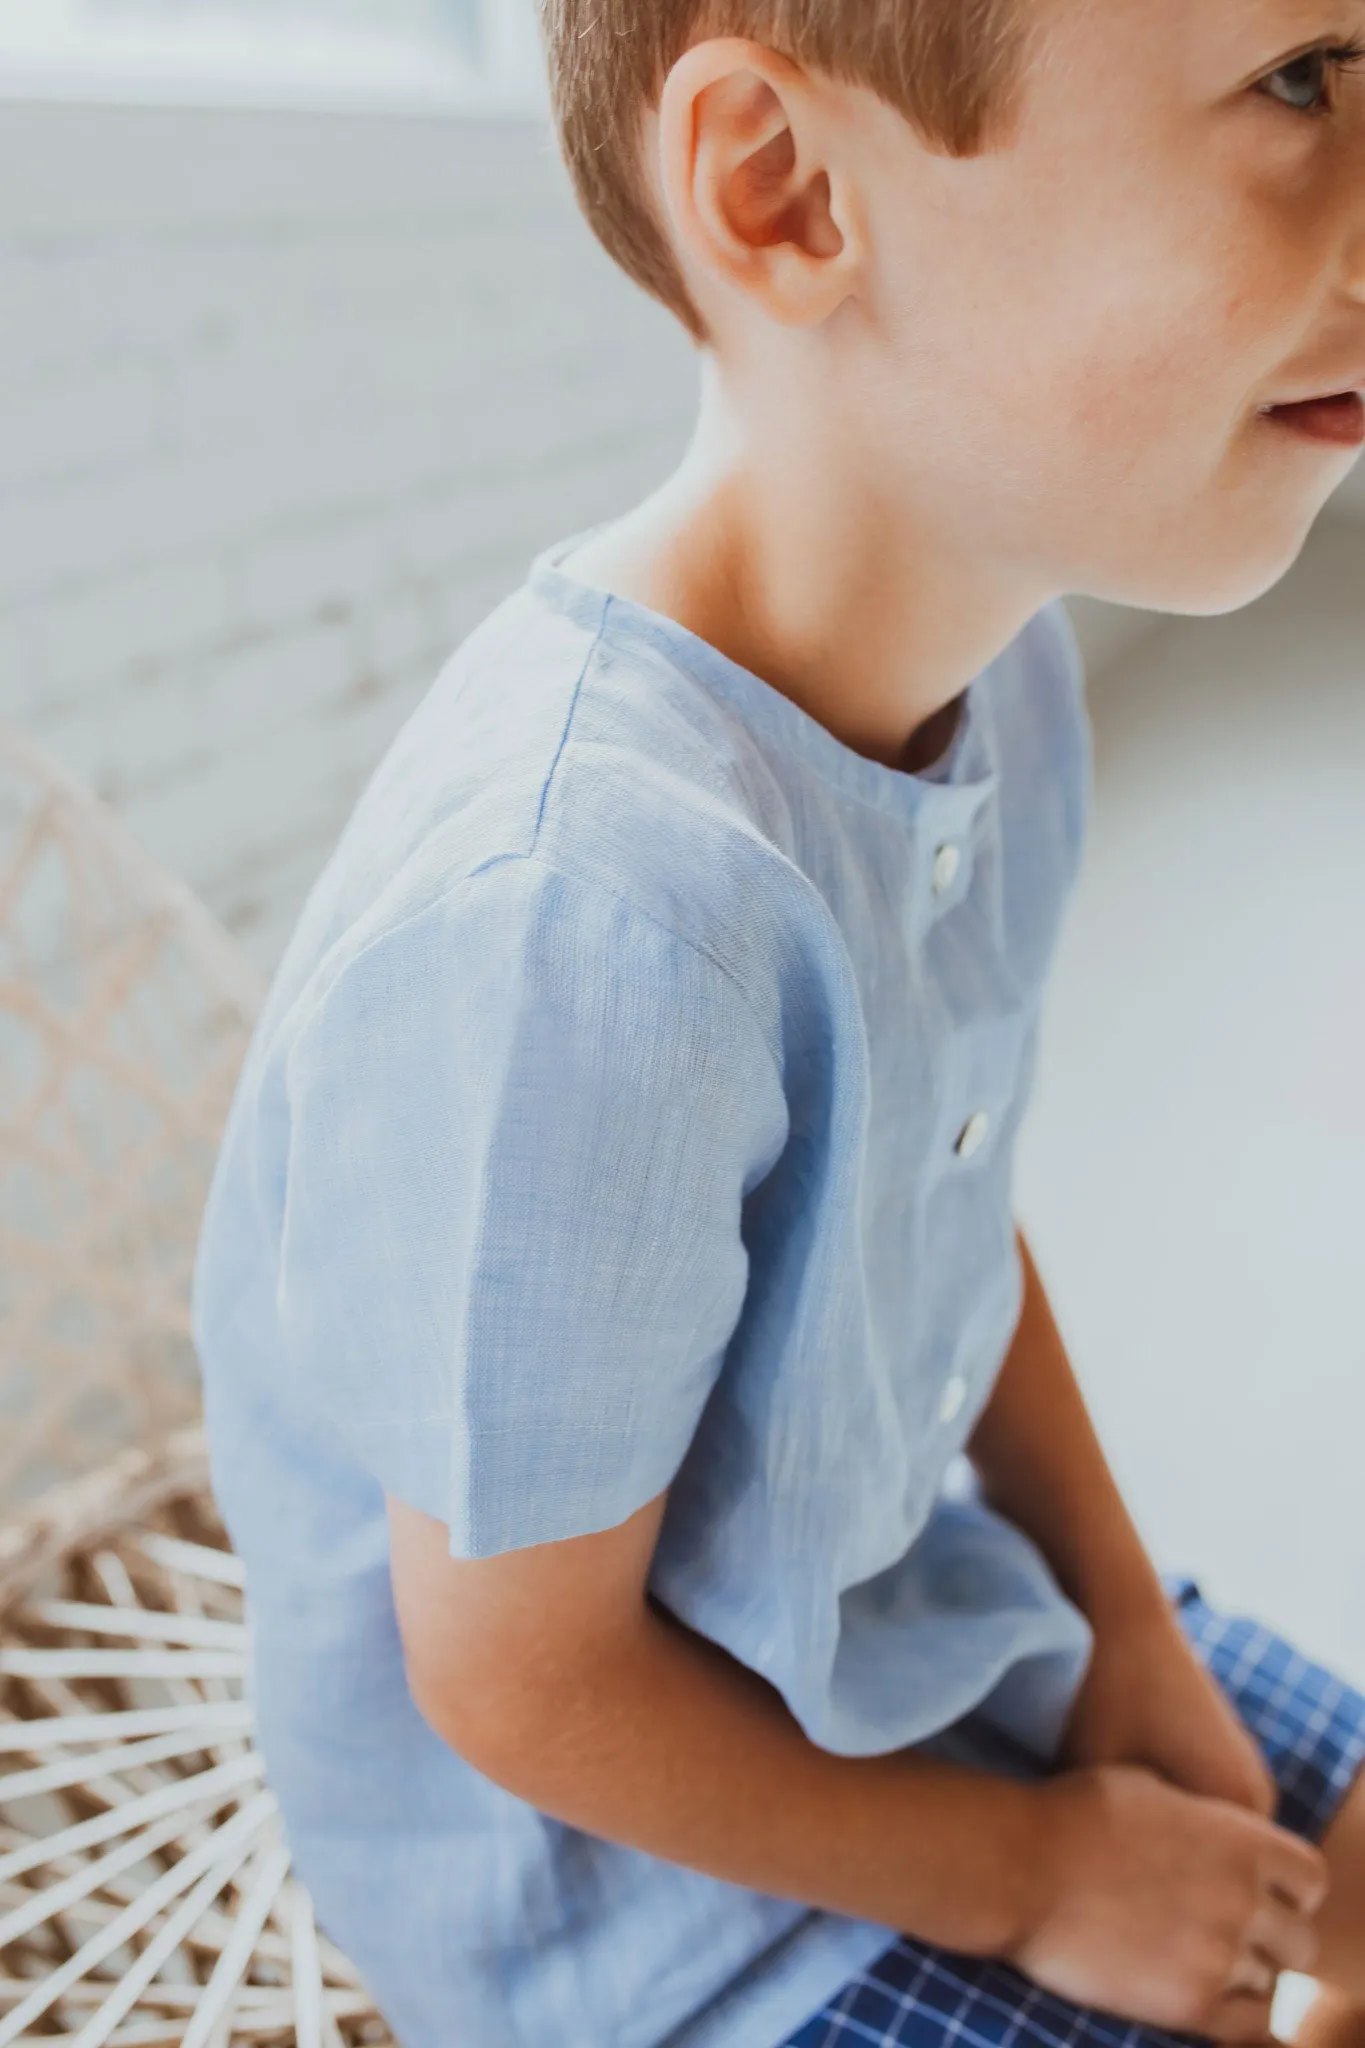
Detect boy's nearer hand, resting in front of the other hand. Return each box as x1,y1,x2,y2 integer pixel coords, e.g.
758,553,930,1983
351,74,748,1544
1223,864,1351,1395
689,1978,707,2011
1007,1763,1326,2042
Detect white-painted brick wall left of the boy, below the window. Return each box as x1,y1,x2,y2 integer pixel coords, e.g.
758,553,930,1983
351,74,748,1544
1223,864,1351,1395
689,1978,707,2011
0,104,694,967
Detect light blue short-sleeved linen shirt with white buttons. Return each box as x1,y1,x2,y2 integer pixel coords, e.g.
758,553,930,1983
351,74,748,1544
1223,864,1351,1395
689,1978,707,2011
194,537,1091,2048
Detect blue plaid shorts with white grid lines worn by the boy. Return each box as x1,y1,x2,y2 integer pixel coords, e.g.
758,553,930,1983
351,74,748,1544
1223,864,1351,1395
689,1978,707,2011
782,1579,1365,2048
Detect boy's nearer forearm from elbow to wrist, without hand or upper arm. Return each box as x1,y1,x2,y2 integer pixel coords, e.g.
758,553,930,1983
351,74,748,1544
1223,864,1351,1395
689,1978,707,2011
422,1610,1046,1954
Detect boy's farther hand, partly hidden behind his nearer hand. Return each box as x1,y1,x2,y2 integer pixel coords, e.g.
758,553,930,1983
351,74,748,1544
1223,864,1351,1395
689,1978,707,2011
1062,1602,1279,1819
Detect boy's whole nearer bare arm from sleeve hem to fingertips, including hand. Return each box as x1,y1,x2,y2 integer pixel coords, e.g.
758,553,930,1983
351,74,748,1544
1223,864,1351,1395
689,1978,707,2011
389,1497,1322,2040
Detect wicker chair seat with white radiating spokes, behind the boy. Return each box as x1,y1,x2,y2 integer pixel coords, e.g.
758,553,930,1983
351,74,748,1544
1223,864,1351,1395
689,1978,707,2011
0,1430,393,2048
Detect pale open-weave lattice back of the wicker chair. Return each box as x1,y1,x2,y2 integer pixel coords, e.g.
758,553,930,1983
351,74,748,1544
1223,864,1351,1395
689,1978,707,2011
0,729,260,1513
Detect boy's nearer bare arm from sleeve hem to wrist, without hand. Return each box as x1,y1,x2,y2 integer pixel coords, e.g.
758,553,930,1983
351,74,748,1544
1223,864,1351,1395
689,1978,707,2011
389,1497,1040,1954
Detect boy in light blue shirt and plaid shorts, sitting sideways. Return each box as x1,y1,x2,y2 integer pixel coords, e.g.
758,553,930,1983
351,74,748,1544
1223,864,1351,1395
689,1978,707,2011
196,0,1365,2048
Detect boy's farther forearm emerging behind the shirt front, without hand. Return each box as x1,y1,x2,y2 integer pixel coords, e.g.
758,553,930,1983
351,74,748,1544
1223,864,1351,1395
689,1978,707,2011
968,1235,1164,1620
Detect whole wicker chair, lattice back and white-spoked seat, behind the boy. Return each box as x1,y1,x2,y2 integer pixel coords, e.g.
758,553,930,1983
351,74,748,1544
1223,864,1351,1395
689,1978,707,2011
0,731,391,2048
